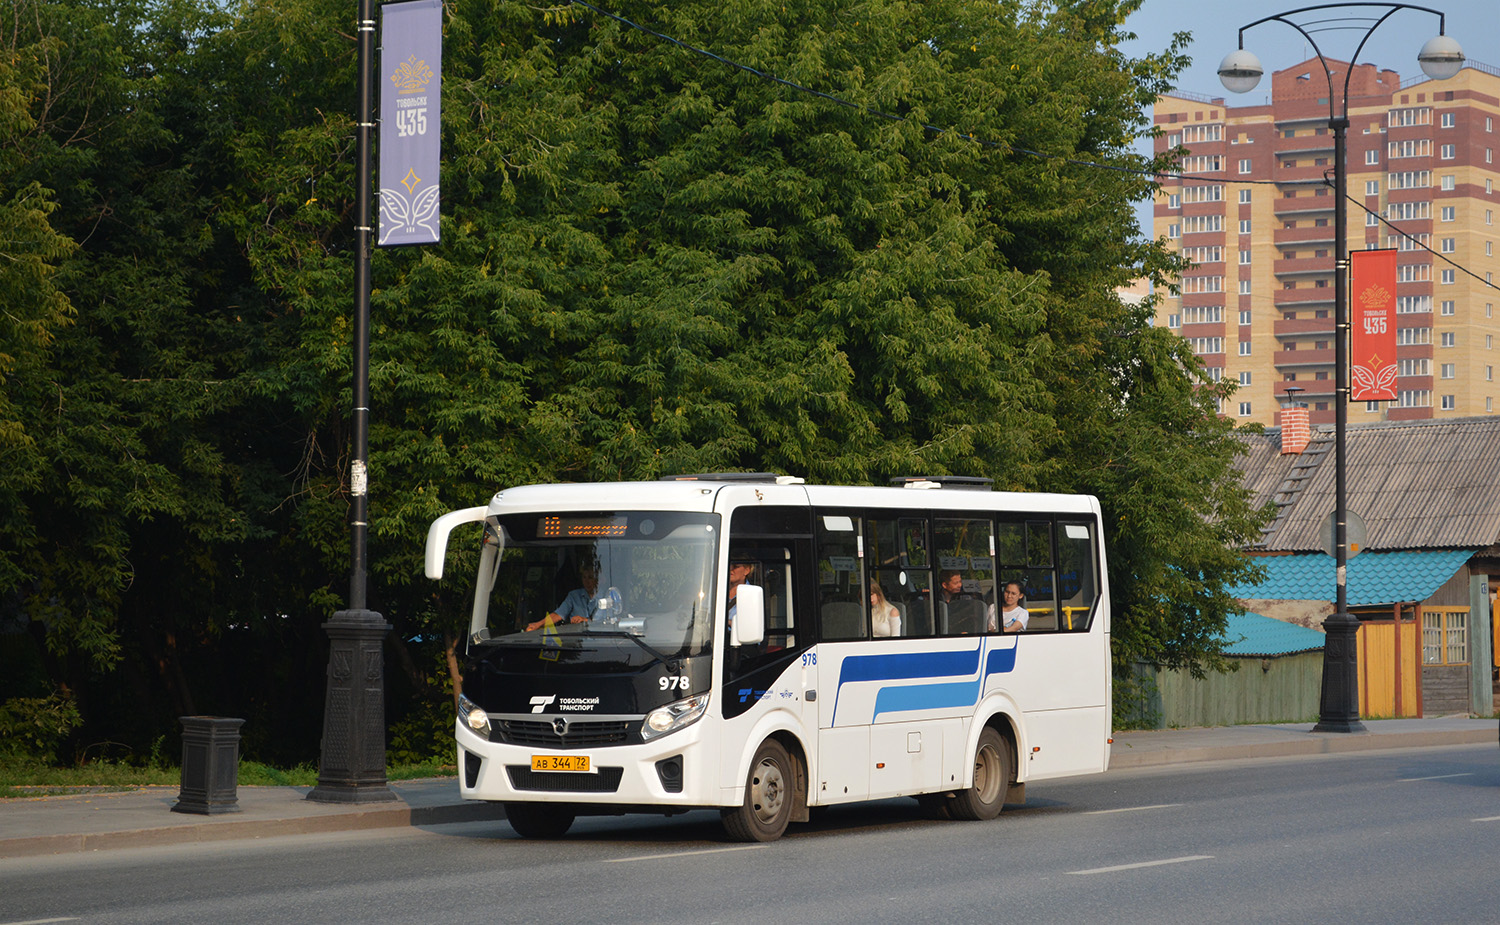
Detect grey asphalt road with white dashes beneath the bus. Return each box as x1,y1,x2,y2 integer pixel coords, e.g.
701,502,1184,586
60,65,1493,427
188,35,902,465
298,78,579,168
0,745,1500,925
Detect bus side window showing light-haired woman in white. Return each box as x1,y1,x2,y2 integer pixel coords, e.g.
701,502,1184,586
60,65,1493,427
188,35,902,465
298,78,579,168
864,517,933,636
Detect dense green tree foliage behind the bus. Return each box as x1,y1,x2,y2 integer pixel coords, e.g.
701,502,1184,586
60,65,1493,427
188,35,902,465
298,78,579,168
0,0,1257,757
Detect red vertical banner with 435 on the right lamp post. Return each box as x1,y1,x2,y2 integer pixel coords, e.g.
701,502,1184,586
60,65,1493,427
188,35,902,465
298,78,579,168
1349,250,1397,402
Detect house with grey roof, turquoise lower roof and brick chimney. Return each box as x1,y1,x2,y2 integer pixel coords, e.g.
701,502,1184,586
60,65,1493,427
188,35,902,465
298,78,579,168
1226,408,1500,717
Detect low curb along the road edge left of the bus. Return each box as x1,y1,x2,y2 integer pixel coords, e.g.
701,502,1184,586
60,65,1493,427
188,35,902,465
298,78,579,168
0,804,506,859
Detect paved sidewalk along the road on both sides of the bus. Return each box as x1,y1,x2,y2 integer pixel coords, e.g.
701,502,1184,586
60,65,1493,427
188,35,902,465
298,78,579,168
0,717,1497,858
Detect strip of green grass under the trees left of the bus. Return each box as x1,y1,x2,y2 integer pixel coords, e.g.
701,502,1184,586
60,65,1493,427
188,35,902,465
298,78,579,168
0,759,458,799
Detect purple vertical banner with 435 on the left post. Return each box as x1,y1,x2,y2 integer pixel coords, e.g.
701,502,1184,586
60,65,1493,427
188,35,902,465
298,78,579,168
378,0,443,246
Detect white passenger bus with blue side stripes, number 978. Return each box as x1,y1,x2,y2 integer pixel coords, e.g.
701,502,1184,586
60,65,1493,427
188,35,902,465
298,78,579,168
426,474,1110,841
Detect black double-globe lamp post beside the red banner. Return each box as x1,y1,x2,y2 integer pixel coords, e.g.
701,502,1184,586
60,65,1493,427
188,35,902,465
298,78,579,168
1218,3,1464,732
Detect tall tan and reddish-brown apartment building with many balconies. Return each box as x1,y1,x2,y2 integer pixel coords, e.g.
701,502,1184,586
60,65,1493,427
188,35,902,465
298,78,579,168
1154,58,1500,424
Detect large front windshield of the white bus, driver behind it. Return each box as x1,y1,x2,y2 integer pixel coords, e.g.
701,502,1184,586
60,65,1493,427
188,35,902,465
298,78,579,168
480,511,719,658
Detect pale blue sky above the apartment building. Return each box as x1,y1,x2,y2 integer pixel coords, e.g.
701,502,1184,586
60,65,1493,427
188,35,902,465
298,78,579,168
1121,0,1500,234
